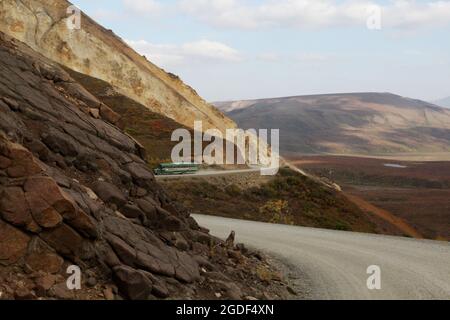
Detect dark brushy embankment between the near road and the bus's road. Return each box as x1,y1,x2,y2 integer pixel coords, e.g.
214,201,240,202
161,168,394,233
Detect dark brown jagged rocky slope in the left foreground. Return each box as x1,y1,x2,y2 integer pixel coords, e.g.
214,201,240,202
0,33,287,299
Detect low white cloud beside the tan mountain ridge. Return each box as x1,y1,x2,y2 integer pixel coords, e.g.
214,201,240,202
126,40,242,68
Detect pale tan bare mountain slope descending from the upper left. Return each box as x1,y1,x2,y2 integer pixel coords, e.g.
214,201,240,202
0,0,235,130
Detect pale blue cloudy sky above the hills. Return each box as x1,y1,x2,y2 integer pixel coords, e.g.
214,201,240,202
72,0,450,101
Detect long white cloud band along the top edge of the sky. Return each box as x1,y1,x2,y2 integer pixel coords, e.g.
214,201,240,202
178,0,450,29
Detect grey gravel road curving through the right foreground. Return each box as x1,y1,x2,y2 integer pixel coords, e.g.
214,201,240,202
194,215,450,299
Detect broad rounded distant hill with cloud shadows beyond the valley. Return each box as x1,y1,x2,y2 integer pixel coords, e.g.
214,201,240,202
215,93,450,155
